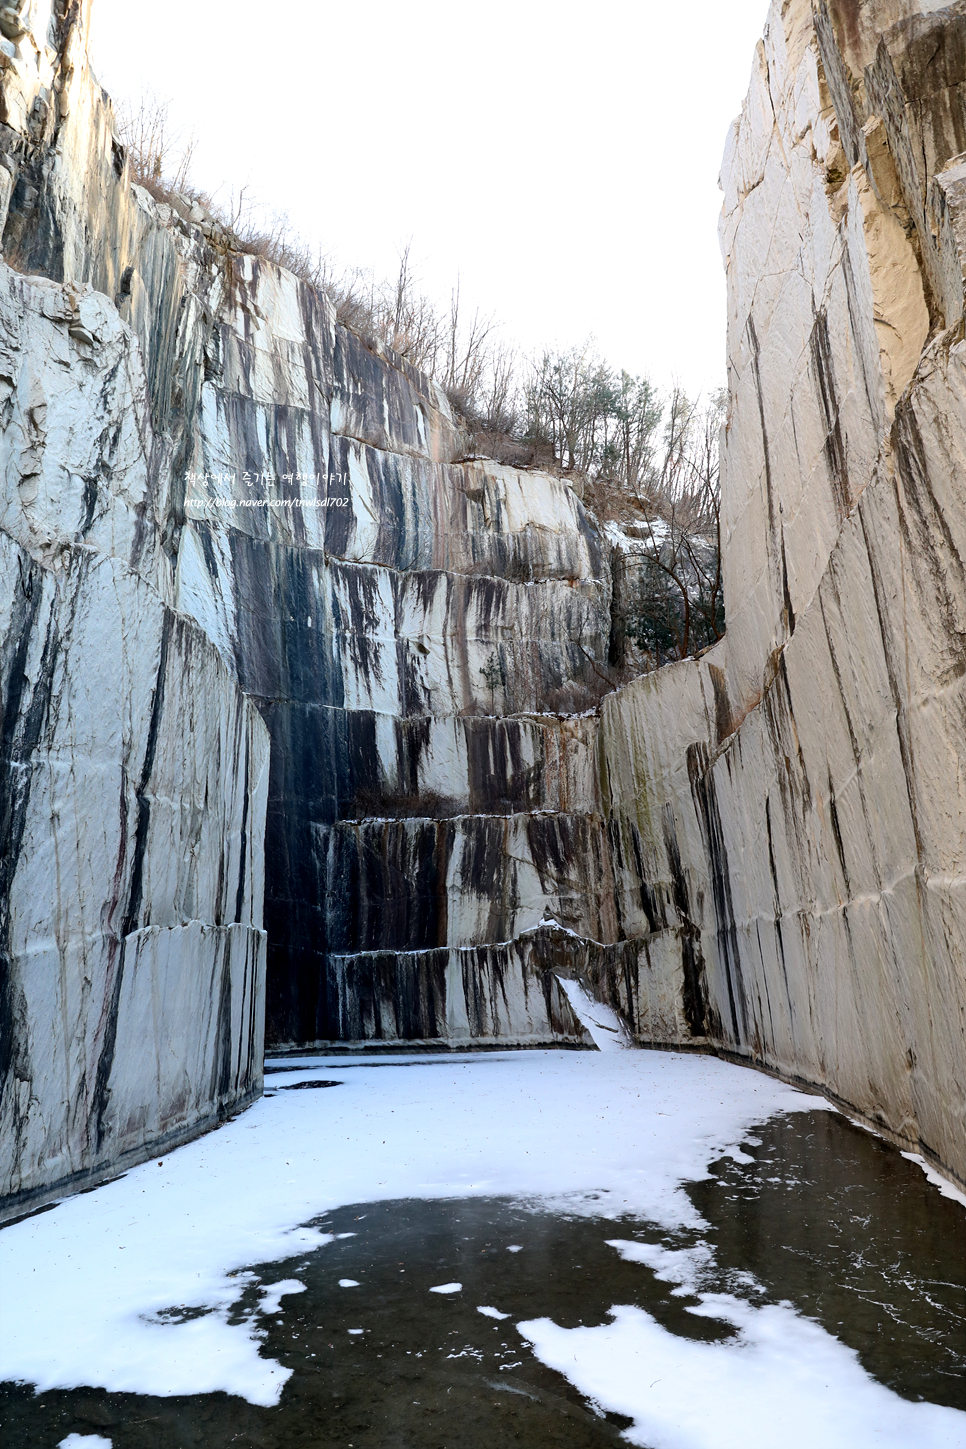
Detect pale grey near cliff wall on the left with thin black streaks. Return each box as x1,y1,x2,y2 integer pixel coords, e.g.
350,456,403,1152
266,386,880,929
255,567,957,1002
0,3,268,1216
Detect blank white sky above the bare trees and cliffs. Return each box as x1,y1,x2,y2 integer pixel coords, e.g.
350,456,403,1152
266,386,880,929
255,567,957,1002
93,0,768,393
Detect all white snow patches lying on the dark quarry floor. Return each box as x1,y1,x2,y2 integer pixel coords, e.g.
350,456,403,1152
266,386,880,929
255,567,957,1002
0,1052,966,1449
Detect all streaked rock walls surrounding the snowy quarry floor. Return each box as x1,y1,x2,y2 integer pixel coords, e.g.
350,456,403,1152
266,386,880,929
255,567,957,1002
0,0,966,1210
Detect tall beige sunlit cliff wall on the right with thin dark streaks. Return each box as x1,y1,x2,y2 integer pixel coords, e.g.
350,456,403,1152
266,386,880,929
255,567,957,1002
601,3,966,1178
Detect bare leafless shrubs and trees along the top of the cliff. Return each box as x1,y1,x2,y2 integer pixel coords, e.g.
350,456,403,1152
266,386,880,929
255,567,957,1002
117,94,724,667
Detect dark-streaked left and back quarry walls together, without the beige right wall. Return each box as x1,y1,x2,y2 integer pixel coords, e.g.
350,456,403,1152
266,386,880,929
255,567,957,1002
0,0,613,1228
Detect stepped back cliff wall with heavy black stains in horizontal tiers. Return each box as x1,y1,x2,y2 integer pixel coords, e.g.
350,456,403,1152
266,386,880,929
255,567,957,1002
178,273,613,1043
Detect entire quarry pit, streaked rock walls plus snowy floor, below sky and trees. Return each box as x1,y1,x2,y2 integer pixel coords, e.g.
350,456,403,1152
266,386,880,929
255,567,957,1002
0,0,966,1449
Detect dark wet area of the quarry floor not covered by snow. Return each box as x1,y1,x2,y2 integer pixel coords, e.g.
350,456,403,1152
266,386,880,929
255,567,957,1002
0,1111,966,1449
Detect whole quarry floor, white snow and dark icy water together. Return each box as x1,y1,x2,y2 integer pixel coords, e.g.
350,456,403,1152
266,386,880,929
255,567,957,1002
0,1051,966,1449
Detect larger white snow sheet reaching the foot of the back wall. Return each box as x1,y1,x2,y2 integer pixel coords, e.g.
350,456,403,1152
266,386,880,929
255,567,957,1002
0,1052,909,1404
